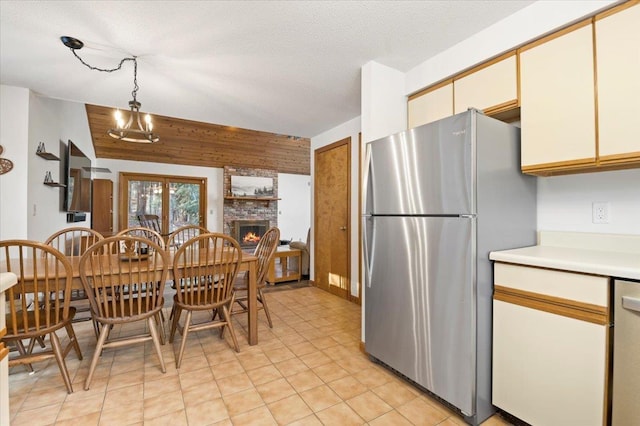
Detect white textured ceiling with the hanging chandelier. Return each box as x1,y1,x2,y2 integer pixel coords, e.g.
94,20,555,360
0,0,532,137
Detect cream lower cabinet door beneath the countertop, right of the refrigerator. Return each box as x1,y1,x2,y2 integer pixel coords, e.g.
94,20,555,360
492,300,607,426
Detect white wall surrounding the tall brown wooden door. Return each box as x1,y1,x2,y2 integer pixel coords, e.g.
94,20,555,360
309,117,364,296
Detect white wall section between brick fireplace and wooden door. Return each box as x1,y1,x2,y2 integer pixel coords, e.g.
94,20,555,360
278,173,311,241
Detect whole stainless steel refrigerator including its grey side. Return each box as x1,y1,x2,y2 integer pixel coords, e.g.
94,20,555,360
363,109,536,424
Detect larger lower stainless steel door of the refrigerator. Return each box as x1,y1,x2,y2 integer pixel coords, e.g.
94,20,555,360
364,216,476,415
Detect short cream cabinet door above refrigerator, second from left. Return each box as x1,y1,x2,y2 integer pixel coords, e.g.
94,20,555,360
453,54,518,115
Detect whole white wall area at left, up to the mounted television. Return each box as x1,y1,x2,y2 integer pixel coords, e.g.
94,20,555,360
0,85,93,241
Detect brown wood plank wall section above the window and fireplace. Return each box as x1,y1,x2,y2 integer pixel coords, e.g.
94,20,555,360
86,104,311,175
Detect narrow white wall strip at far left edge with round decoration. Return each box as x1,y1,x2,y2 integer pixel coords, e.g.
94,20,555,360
0,85,29,240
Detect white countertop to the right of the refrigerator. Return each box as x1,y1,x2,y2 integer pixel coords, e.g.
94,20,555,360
489,233,640,280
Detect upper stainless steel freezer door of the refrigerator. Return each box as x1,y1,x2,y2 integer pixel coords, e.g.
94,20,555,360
365,113,476,215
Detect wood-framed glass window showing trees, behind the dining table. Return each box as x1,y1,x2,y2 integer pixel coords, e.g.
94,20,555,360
118,173,207,235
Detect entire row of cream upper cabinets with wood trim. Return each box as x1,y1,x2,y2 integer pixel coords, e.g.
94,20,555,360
407,1,640,176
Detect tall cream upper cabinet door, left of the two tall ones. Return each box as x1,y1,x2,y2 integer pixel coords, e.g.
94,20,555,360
520,24,596,172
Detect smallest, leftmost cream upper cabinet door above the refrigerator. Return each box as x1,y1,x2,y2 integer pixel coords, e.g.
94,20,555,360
407,83,453,129
